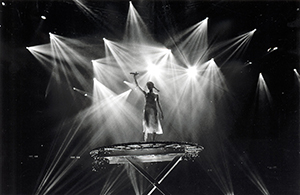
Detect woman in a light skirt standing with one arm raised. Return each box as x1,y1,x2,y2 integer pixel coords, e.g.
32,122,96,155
131,72,164,141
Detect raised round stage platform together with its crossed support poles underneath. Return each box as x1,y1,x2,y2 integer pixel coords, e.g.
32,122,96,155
90,142,204,195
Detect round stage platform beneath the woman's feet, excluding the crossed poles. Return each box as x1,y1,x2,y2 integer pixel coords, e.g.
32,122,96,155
90,142,204,165
